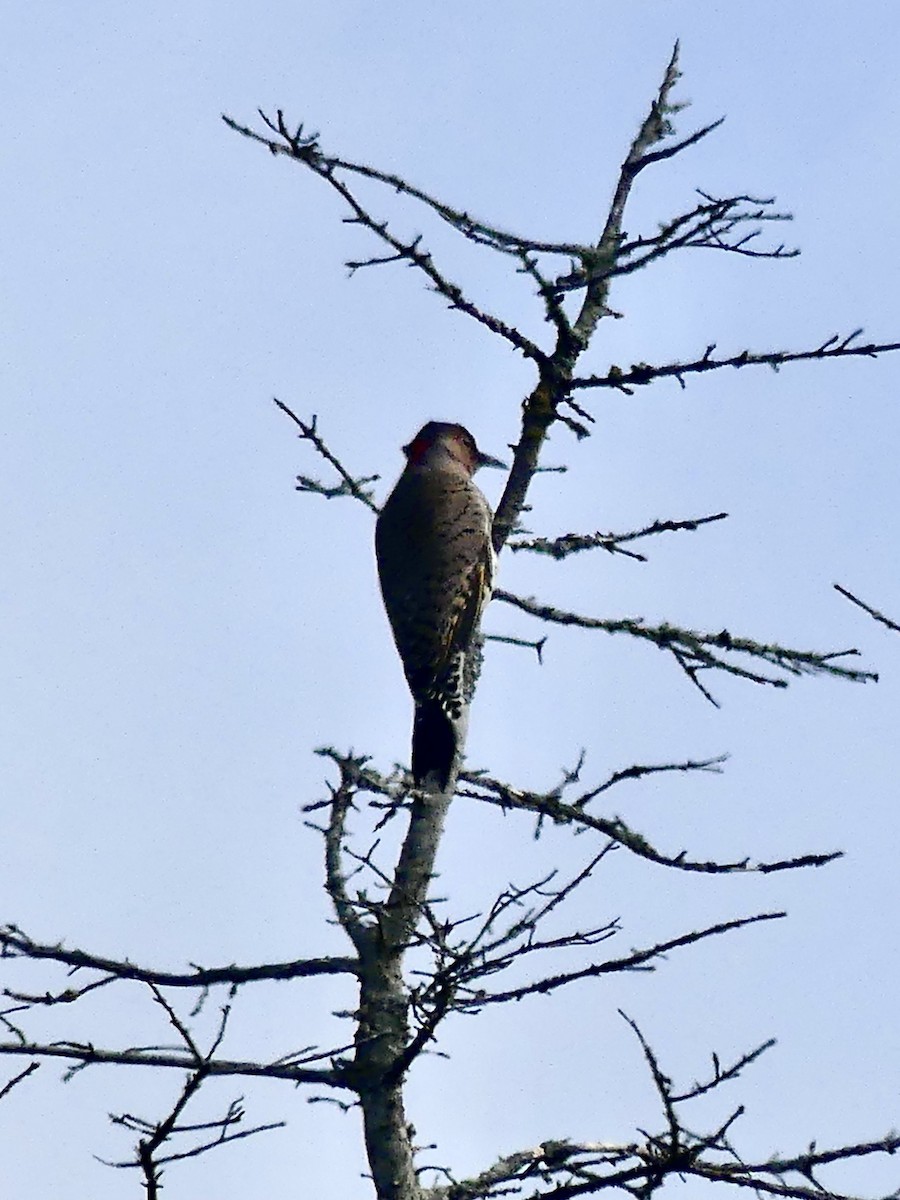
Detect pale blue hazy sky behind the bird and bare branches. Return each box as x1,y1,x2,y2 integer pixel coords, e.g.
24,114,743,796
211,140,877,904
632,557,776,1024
0,0,900,1200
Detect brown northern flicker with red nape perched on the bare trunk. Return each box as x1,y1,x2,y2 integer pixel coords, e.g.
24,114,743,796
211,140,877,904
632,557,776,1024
376,421,503,791
